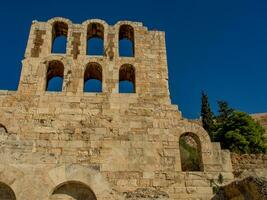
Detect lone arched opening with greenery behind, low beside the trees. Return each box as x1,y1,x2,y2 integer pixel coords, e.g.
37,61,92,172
179,133,203,171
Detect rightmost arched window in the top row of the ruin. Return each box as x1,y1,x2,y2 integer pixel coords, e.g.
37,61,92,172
119,25,134,57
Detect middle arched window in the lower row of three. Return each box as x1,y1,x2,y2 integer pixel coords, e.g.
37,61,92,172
83,62,102,92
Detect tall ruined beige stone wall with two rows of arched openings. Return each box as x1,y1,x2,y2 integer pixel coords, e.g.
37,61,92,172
0,18,233,200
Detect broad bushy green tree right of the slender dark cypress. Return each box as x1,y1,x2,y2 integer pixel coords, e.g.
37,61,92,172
216,108,267,153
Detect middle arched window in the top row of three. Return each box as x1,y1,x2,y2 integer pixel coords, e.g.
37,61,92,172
86,23,104,55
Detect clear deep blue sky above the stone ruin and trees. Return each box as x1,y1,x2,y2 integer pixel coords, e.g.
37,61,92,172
0,0,267,118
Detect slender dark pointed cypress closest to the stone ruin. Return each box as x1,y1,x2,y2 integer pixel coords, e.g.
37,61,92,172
201,92,215,141
